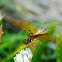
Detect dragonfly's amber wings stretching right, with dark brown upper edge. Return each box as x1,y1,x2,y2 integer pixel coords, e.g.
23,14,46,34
33,33,55,41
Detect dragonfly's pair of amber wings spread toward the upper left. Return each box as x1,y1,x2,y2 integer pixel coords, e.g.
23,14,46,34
10,19,37,35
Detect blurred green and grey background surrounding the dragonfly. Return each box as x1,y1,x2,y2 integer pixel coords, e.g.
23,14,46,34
0,0,62,62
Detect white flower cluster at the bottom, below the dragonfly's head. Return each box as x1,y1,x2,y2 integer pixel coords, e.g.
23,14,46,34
14,48,33,62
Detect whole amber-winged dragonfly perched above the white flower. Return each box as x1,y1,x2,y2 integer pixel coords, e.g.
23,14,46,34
10,19,54,44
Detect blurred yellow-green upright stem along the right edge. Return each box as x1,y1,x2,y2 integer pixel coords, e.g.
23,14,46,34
56,33,62,62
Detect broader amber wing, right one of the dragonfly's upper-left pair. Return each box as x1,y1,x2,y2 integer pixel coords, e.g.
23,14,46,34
20,20,38,34
